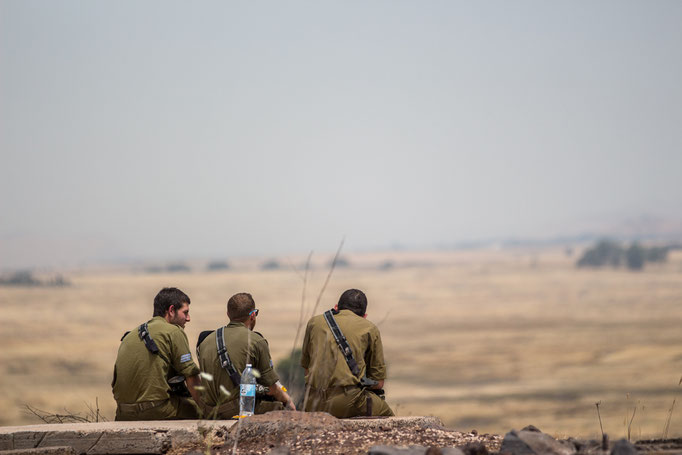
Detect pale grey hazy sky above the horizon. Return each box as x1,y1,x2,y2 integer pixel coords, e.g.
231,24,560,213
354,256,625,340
0,0,682,267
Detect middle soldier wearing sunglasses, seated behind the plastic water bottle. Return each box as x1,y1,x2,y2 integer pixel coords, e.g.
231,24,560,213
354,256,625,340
197,293,296,419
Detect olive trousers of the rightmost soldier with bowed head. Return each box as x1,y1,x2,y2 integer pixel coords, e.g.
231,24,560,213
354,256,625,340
304,386,395,419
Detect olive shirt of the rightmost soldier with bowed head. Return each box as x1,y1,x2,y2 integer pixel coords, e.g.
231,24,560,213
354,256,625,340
301,310,386,389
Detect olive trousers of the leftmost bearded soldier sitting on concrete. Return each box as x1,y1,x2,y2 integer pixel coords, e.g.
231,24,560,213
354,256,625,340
116,395,200,420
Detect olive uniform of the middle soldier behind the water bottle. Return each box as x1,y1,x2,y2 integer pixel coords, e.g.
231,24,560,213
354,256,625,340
197,322,283,419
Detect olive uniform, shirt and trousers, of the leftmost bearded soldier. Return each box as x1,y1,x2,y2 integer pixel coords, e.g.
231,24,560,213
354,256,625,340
111,316,199,420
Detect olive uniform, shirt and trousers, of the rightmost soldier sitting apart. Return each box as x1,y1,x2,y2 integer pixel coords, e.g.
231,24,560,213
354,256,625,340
301,310,394,418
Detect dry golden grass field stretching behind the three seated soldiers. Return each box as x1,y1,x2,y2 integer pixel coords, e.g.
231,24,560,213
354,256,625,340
0,246,682,438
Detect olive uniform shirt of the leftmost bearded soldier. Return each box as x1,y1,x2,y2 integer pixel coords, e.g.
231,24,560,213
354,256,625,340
112,316,199,403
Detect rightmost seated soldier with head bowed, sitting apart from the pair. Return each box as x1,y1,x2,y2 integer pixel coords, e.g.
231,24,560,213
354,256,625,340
301,289,394,418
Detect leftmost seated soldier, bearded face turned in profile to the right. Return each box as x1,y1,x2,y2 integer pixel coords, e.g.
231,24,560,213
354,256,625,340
111,288,200,420
